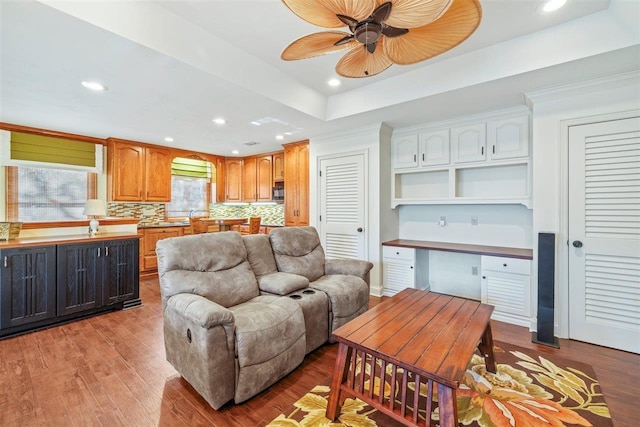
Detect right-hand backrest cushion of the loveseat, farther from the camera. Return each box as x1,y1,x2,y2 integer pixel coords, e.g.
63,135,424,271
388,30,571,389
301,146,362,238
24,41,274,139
269,227,325,282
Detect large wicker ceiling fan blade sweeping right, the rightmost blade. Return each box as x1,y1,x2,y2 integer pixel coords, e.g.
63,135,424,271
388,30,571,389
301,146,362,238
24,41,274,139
384,0,482,65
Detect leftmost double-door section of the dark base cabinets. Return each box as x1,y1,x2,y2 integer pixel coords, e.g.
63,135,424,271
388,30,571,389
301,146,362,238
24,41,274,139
0,245,56,329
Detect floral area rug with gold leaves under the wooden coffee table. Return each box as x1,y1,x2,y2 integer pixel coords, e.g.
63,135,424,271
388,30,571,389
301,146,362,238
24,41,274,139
268,342,613,427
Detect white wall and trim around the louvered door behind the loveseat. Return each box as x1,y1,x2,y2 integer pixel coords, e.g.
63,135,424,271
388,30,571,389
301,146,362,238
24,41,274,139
309,124,398,296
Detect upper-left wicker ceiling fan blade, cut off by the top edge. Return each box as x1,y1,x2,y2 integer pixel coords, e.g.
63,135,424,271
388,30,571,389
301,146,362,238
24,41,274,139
282,0,376,28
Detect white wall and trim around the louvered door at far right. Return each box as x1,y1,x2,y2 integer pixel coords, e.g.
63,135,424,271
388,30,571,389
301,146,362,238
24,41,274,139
527,71,640,338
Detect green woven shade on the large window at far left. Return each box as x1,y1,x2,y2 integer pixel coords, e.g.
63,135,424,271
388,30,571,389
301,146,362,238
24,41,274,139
11,132,96,167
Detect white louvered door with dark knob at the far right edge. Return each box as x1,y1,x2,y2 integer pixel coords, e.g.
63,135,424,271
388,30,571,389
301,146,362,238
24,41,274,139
569,118,640,353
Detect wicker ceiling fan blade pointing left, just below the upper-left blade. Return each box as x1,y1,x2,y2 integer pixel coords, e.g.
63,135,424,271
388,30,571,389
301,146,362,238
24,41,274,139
280,31,360,61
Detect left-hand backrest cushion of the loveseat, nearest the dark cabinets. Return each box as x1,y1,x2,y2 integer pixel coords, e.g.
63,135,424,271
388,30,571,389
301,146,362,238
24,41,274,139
156,231,260,307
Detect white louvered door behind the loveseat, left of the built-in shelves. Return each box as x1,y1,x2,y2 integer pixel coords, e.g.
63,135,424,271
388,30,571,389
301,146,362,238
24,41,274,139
319,154,367,260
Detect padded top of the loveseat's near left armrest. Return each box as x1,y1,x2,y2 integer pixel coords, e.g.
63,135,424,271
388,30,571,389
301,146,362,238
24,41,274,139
167,294,234,329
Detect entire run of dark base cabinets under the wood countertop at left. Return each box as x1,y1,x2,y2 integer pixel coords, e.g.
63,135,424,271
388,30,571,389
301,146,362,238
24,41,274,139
0,238,141,337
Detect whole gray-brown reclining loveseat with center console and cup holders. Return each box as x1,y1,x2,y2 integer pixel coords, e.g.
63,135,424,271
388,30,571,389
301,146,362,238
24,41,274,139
156,227,373,409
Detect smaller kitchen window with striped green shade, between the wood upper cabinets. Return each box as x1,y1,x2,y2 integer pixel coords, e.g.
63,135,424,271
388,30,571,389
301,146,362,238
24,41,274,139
166,157,213,218
